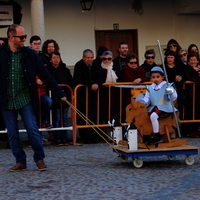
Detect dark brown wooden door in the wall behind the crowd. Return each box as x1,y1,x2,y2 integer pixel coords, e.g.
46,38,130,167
95,29,138,58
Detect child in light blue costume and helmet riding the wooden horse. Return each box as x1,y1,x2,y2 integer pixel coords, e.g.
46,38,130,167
139,66,177,144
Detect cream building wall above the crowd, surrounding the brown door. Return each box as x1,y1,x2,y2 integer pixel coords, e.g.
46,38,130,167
0,0,200,66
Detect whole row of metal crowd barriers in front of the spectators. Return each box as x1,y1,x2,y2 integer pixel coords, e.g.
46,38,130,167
0,81,200,145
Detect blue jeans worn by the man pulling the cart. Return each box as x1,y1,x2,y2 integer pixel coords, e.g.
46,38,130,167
2,103,45,165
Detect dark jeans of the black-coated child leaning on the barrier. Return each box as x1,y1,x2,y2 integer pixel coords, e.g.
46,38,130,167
52,107,69,142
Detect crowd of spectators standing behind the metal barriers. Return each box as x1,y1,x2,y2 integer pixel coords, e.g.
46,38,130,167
1,35,200,146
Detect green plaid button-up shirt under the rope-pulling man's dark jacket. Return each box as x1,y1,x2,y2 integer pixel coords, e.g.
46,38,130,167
6,50,31,110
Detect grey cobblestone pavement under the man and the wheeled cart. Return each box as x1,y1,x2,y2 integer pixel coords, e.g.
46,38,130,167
0,138,200,200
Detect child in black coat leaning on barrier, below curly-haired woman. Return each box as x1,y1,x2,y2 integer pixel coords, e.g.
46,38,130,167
47,52,73,146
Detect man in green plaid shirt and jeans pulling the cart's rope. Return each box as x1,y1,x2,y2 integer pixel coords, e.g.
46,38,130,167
0,24,66,172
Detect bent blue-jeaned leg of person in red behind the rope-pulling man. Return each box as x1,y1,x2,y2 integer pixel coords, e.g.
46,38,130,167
40,94,53,123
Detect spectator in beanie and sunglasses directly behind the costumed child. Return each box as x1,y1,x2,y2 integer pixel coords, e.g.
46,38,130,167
141,49,156,78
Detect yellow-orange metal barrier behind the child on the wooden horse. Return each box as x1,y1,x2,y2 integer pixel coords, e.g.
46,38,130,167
74,81,200,134
